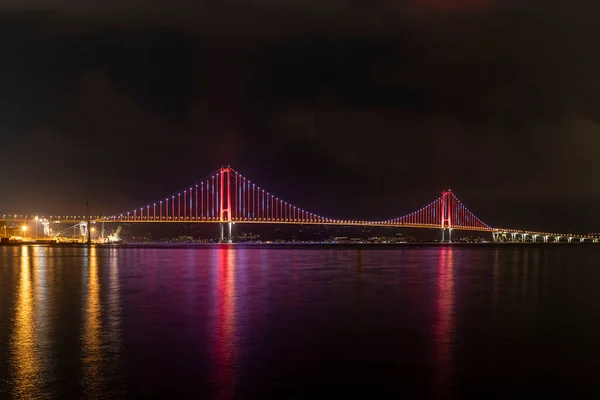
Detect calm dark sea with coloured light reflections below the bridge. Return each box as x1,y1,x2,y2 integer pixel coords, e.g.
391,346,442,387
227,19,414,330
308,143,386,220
0,245,600,399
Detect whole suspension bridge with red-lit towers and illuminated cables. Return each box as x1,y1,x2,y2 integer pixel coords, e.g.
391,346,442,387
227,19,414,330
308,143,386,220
0,167,600,243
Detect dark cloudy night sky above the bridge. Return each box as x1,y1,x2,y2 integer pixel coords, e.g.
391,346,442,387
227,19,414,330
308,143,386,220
0,0,600,232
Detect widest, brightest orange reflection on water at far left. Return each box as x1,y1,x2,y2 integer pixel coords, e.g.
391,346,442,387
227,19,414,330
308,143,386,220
10,246,41,399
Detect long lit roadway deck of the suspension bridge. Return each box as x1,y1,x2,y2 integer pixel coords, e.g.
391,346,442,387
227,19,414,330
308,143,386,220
0,214,600,243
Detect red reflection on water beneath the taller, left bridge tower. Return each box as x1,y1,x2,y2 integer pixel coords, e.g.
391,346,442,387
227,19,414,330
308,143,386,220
214,246,236,399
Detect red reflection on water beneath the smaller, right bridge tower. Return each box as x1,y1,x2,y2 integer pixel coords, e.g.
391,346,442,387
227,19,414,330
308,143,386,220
434,246,455,390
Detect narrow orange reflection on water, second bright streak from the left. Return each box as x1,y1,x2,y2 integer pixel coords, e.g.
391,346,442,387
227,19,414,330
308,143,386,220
82,247,102,395
